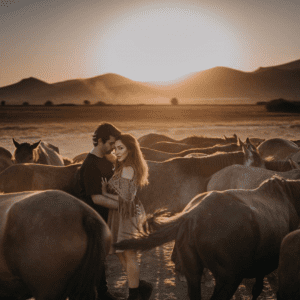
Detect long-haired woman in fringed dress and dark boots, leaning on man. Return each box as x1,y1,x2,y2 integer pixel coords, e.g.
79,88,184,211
102,134,153,300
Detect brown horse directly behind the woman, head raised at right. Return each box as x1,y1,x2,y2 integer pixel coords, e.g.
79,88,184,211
137,145,264,214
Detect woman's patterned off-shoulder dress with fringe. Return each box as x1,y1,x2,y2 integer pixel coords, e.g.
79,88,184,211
107,174,146,254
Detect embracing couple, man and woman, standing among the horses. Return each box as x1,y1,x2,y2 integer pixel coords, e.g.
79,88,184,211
79,123,153,300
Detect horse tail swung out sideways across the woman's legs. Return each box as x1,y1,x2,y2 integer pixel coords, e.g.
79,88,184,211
114,213,187,251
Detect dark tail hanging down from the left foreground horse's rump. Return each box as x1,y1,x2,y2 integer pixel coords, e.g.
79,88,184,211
61,211,110,300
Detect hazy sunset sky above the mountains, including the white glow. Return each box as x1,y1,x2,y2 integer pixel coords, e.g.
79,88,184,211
0,0,300,87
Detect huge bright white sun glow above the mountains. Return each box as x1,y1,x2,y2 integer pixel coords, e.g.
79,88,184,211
94,7,236,81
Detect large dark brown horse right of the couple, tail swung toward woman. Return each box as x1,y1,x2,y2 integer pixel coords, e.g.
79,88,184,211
115,176,300,300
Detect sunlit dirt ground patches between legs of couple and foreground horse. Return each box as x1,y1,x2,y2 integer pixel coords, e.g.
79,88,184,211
106,242,277,300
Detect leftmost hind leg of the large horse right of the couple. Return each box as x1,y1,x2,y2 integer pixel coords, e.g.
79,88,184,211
174,242,204,300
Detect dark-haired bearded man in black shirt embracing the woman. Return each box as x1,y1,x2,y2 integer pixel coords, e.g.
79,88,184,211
79,123,121,300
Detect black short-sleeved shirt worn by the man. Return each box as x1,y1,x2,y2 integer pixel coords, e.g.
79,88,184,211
79,153,114,222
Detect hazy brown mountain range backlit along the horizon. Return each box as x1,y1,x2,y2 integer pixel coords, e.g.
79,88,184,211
0,59,300,105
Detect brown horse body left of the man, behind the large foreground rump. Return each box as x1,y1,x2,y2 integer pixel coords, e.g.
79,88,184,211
0,164,81,195
